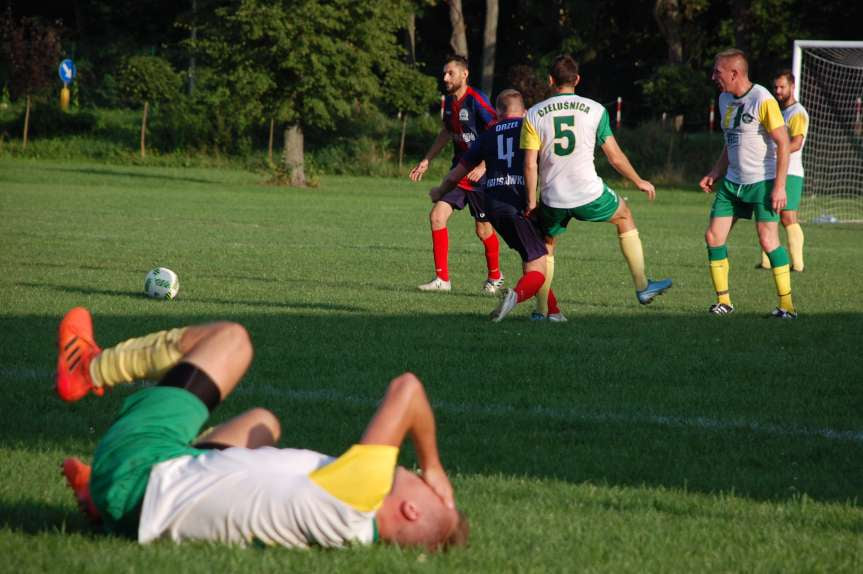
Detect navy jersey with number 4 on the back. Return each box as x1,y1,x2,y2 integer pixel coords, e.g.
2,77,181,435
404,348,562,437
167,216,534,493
461,118,527,212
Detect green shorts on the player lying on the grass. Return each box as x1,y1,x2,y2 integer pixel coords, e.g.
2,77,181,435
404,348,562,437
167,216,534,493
90,387,209,537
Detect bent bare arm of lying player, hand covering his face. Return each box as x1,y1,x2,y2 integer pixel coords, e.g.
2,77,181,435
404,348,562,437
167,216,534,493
360,373,455,508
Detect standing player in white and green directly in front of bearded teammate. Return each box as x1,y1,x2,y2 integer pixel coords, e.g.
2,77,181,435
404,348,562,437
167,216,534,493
699,49,797,319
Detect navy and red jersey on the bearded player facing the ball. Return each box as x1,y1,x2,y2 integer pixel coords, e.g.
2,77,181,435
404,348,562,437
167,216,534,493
443,86,497,190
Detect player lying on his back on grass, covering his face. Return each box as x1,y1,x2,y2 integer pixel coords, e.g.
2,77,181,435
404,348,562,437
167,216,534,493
57,307,468,549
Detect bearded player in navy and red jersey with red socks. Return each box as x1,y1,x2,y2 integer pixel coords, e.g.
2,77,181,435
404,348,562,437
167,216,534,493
410,55,503,294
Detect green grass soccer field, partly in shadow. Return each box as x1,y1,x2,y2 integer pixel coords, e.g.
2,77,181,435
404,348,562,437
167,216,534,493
0,160,863,573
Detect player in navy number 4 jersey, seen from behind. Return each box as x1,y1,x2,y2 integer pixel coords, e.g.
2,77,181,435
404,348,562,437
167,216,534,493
429,90,564,321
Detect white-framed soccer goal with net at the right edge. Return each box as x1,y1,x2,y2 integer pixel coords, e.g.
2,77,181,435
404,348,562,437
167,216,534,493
793,40,863,223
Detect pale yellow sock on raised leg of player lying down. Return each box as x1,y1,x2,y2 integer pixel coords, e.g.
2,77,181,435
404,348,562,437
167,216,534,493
90,327,187,387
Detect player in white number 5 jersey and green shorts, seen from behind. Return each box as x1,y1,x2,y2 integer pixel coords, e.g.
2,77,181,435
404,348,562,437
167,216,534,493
521,55,671,319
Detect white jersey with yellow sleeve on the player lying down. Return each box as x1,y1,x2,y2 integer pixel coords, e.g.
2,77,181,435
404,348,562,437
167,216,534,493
138,445,398,548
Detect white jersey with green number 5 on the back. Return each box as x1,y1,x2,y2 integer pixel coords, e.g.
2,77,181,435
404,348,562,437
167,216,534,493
521,94,612,209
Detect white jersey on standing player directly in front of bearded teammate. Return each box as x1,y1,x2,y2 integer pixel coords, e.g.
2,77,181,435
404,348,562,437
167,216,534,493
719,84,785,185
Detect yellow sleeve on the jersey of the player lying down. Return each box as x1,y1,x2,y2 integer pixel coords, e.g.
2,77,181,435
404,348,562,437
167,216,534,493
309,444,399,512
